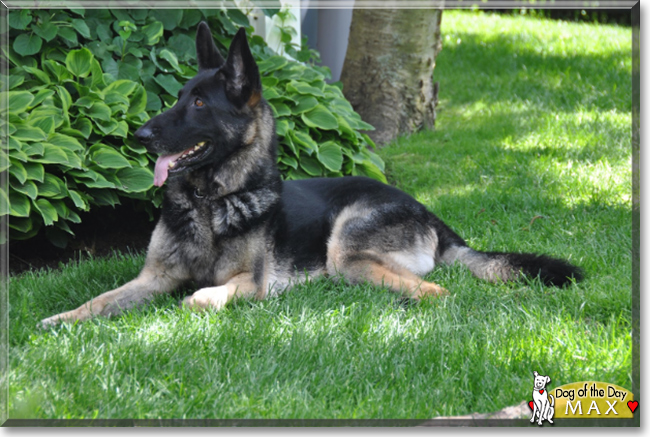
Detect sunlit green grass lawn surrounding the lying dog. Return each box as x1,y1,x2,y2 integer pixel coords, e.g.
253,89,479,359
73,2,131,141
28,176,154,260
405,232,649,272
8,11,632,418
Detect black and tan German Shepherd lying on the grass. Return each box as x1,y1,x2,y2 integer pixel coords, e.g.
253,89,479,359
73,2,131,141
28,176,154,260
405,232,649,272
42,23,582,326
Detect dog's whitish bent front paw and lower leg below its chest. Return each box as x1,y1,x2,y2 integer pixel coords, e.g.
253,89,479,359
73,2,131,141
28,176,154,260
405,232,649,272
183,273,259,310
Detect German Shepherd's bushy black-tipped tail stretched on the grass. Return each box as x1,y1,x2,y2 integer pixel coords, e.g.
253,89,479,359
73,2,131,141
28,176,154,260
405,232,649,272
432,214,584,287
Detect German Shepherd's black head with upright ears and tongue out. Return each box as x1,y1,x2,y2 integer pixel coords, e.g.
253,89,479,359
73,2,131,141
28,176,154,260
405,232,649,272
135,22,262,186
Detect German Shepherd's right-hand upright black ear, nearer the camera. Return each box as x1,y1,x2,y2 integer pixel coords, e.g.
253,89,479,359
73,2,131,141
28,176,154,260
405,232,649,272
220,27,262,108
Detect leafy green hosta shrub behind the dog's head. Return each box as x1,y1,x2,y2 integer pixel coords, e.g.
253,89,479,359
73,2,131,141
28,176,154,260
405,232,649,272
0,9,385,246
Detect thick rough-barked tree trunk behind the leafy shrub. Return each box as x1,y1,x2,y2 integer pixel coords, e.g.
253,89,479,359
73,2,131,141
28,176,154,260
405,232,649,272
341,9,442,145
